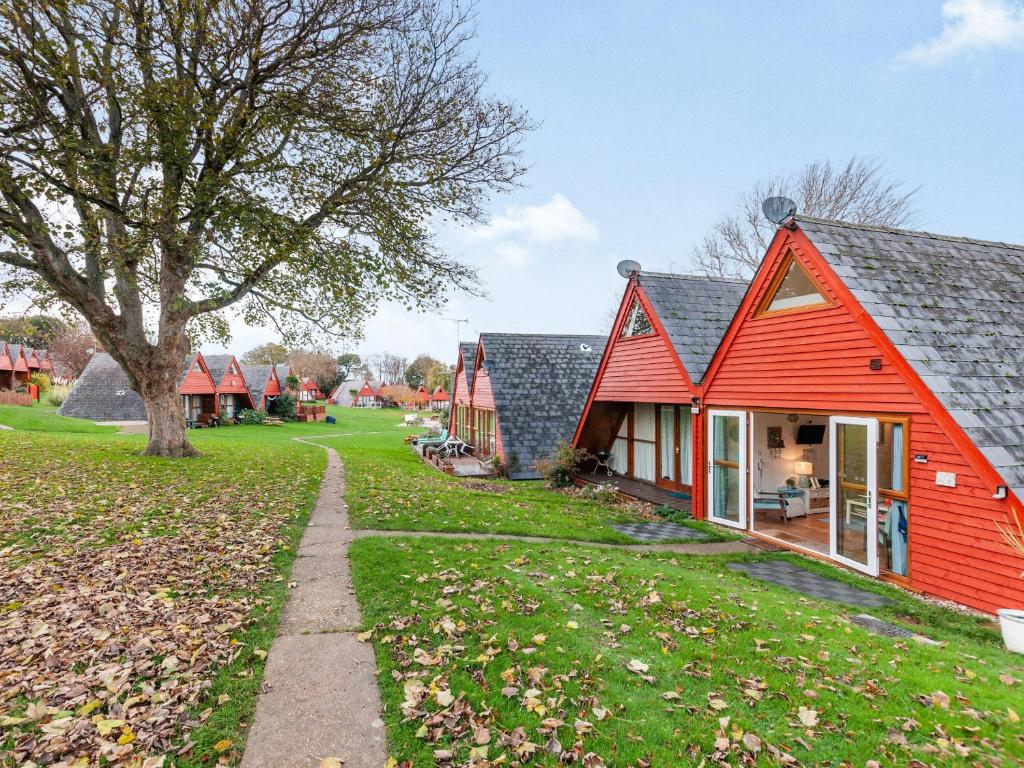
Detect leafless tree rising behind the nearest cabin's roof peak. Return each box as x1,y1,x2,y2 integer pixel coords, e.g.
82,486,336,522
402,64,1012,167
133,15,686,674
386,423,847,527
693,158,916,278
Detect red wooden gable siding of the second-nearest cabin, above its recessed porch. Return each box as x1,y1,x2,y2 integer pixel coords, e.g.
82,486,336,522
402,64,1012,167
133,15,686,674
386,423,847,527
592,285,694,402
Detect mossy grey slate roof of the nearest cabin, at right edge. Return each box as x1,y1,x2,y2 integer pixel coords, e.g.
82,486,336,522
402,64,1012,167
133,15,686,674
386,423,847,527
797,216,1024,497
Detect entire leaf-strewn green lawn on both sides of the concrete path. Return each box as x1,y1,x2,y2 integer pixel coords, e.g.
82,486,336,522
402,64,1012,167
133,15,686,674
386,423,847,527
0,407,1024,767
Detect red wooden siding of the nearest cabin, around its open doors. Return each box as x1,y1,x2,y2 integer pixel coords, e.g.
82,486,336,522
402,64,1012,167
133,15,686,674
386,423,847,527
694,231,1024,612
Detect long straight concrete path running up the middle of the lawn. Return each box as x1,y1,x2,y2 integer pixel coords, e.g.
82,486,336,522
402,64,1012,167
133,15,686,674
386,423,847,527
242,440,387,768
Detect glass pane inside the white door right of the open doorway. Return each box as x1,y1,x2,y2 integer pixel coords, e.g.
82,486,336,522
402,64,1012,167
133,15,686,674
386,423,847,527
833,423,870,565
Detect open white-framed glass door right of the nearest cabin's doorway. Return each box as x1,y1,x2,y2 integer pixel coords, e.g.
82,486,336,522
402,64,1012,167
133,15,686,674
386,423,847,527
828,416,879,575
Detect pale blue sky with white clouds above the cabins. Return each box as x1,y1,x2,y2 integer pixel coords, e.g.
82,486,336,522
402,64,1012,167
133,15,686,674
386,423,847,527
204,0,1024,362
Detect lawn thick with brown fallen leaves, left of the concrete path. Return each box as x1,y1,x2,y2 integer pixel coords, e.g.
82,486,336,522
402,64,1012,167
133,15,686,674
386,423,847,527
0,409,326,766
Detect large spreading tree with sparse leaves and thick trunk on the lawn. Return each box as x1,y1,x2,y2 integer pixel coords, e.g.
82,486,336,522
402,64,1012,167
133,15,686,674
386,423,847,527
0,0,529,456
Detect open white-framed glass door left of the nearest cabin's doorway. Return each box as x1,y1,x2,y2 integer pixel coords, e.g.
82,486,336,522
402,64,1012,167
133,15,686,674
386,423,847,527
708,410,746,528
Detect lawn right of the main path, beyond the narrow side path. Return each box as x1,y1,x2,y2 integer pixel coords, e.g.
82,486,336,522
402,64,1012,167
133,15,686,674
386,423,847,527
325,409,684,543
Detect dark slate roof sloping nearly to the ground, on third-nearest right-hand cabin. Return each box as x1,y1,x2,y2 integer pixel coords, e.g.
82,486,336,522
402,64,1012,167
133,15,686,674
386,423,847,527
479,334,607,479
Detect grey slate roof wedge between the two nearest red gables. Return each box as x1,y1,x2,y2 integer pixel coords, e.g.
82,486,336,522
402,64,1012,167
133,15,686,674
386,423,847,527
637,272,750,383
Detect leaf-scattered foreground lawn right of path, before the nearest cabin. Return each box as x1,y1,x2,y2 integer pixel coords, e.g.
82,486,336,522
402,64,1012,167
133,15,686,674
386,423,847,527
351,539,1024,768
